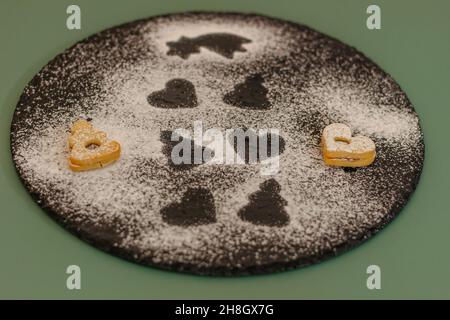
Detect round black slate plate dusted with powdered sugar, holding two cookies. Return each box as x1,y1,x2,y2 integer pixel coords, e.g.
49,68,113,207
11,13,424,275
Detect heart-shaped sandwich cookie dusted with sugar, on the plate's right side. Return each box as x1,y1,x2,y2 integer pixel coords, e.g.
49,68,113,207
321,123,376,167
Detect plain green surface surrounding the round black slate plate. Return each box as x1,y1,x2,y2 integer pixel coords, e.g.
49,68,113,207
0,0,450,299
